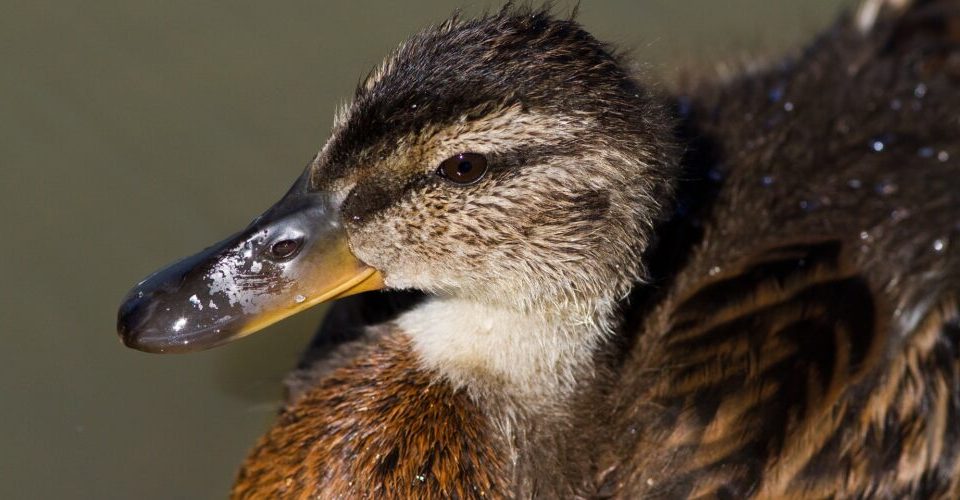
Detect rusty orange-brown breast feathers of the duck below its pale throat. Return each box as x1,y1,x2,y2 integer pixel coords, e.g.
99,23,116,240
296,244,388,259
232,332,507,499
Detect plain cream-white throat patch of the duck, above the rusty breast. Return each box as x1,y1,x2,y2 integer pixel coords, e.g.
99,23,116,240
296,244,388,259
397,297,613,413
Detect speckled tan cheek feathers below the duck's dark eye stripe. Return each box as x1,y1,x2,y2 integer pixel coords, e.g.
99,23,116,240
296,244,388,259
359,145,660,314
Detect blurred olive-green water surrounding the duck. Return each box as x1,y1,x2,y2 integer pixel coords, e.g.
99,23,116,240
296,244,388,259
0,0,853,499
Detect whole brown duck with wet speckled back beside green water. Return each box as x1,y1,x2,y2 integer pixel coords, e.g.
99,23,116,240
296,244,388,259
118,0,960,499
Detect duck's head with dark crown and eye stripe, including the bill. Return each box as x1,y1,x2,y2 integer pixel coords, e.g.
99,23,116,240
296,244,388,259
118,9,678,352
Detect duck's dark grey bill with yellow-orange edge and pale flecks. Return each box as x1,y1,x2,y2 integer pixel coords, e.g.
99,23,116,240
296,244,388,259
117,177,383,353
